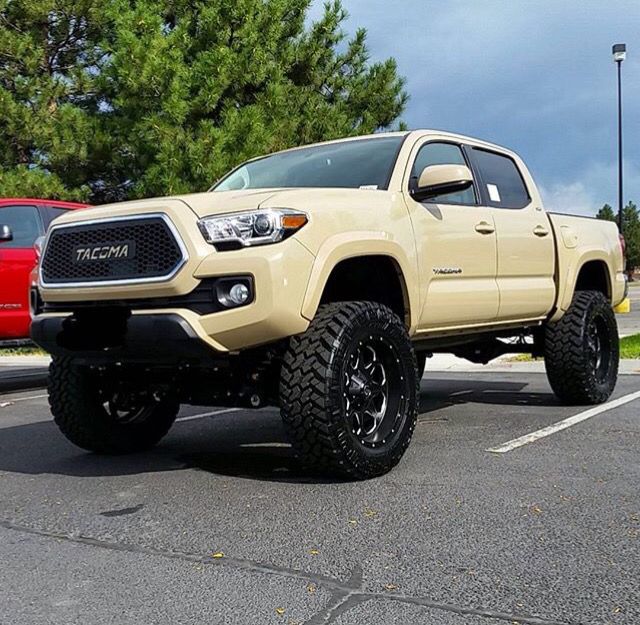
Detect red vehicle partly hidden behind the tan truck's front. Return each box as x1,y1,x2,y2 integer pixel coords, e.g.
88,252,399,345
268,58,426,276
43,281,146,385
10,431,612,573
0,198,87,340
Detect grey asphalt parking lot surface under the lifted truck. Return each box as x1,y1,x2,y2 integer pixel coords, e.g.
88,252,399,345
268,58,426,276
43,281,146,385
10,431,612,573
0,371,640,625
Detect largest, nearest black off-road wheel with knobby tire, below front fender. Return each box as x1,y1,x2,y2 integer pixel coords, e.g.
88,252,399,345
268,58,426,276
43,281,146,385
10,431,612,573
280,302,419,479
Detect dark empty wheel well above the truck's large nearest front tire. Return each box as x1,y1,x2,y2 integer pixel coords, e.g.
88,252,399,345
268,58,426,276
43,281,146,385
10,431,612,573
320,255,409,324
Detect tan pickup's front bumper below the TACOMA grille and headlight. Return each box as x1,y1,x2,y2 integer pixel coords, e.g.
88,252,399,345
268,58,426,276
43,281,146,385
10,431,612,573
34,233,315,358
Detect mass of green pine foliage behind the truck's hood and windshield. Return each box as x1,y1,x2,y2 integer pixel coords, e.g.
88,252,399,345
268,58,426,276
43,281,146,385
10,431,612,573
0,0,407,202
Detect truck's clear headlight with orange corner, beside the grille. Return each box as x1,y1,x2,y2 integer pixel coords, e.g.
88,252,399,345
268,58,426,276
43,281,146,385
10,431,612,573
198,208,308,250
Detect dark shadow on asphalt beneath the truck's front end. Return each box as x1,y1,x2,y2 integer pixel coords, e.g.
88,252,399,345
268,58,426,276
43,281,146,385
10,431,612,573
0,410,341,483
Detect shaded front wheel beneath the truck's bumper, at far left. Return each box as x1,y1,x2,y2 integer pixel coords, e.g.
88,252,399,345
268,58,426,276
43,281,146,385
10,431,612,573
48,358,180,455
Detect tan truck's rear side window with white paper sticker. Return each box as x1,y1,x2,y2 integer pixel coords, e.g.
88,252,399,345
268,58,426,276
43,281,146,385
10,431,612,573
473,148,531,208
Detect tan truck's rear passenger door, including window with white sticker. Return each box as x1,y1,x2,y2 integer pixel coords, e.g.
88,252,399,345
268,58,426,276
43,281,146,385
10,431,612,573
467,146,556,321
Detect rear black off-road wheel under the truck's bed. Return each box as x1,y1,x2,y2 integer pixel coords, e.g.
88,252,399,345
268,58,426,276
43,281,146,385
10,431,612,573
544,291,620,405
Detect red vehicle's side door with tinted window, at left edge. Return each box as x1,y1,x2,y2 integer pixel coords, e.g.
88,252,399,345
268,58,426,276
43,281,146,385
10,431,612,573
0,205,44,340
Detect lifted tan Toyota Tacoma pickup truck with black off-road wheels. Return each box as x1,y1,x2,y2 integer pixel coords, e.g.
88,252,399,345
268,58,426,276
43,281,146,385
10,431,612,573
32,130,626,478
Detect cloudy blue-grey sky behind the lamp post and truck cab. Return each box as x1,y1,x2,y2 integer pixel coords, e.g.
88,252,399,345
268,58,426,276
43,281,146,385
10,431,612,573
310,0,640,214
